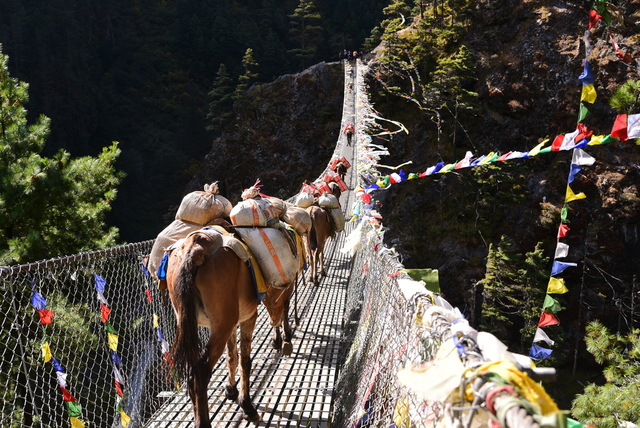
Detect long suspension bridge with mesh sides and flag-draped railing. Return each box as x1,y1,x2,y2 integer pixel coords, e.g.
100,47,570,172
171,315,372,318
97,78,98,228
0,61,562,428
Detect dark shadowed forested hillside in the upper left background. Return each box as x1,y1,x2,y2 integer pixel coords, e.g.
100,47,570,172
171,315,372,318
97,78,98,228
0,0,386,242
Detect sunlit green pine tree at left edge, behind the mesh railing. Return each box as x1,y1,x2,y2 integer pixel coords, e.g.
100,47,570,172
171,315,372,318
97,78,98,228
0,46,122,265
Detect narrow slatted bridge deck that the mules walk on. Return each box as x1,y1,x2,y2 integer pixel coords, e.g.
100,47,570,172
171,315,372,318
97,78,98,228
145,61,356,428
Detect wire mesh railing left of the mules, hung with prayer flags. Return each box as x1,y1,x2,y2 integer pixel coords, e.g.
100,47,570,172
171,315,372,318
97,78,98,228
0,241,180,427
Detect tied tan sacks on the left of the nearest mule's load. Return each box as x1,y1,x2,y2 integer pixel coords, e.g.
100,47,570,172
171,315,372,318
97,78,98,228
147,182,232,282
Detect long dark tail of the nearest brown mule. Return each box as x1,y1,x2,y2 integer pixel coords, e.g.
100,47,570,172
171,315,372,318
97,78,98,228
170,234,208,377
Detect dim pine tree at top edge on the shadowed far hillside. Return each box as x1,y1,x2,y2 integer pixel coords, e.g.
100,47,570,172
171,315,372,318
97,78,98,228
289,0,323,69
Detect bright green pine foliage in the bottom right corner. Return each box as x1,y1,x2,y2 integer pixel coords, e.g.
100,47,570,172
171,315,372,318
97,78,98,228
571,321,640,428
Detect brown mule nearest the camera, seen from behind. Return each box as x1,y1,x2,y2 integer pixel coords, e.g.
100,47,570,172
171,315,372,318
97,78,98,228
167,231,259,428
